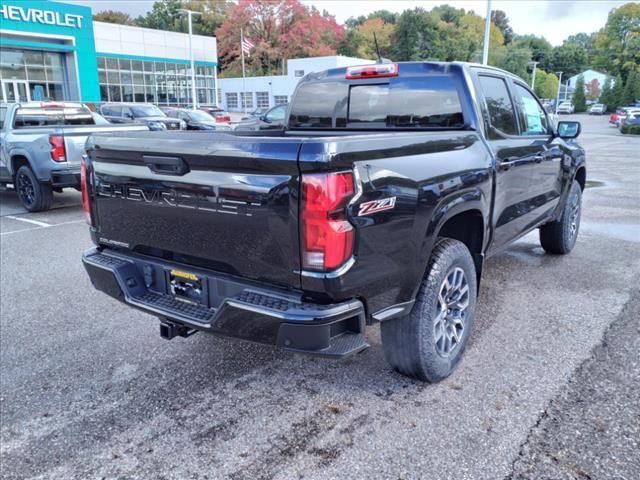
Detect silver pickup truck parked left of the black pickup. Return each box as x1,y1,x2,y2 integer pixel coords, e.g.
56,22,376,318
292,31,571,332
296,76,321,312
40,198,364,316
0,102,148,212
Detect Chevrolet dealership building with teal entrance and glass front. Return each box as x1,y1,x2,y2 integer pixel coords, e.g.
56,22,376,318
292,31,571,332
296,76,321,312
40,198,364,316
0,0,218,105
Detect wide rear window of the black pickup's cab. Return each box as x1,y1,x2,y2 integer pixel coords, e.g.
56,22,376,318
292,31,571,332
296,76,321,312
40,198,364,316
289,74,464,129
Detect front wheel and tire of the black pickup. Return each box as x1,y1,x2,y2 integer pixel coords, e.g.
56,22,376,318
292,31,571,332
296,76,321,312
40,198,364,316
540,180,582,255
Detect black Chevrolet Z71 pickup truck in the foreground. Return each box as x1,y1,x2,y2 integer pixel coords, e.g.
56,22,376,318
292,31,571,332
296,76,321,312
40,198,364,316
82,62,586,381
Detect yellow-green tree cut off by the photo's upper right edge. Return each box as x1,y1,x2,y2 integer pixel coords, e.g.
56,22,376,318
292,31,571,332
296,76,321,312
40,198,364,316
594,2,640,78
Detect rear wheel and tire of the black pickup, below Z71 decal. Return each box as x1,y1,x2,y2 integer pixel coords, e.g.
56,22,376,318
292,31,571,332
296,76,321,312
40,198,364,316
380,238,476,382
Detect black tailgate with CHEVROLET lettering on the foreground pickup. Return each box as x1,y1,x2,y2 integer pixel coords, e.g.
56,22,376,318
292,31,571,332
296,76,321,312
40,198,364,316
87,132,301,287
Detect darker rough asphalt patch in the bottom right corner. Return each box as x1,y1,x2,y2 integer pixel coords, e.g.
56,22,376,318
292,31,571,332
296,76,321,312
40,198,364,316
509,292,640,480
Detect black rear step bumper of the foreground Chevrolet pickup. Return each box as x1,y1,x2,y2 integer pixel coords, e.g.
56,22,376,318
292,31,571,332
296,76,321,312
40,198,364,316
82,248,368,357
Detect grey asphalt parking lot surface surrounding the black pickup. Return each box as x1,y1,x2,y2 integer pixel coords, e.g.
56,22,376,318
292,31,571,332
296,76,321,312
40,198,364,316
0,115,640,480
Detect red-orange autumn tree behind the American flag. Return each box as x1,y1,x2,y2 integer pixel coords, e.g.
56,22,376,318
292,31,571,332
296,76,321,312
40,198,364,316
215,0,344,77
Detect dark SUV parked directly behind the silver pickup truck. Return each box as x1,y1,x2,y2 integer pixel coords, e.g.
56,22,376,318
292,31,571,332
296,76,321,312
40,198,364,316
98,103,187,130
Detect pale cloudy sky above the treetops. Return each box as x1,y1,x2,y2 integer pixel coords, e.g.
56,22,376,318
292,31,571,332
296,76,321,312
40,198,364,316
62,0,628,45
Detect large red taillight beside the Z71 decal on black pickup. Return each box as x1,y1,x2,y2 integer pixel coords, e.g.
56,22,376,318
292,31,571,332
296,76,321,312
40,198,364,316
300,173,354,271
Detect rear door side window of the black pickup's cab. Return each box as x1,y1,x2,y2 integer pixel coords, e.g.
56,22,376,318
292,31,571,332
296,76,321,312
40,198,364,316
478,75,518,139
